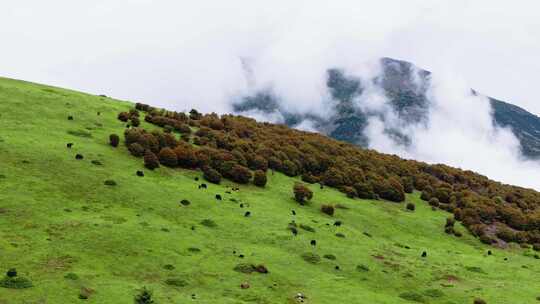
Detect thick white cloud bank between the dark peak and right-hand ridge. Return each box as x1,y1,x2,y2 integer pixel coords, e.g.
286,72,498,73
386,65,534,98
366,73,540,189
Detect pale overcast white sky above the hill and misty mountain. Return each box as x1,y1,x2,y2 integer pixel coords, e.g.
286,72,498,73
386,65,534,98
0,0,540,114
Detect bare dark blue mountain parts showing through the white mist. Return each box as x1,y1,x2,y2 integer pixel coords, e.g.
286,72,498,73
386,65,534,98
233,58,540,159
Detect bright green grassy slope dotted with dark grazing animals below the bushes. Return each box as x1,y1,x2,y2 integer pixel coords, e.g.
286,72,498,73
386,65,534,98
0,79,540,304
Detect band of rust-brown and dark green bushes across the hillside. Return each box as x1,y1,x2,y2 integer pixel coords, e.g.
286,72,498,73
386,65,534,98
110,103,540,249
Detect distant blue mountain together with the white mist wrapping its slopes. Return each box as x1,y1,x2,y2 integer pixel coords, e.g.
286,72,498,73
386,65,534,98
232,58,540,188
